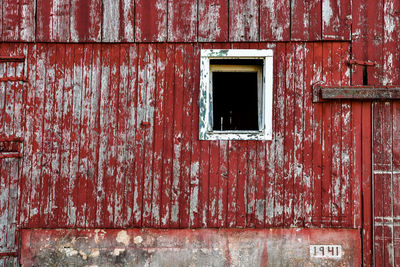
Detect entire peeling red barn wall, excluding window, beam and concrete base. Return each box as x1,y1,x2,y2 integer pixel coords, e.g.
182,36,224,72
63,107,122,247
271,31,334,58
0,0,400,265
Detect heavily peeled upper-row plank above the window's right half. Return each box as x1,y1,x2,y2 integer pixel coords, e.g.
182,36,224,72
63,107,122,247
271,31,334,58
229,0,260,42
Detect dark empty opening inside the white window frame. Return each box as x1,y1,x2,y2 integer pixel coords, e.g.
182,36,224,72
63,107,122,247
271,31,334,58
212,72,259,131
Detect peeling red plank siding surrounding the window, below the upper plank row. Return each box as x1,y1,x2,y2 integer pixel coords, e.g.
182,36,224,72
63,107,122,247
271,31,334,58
0,42,362,231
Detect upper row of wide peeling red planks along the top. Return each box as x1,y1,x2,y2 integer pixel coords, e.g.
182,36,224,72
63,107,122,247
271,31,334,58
0,0,352,42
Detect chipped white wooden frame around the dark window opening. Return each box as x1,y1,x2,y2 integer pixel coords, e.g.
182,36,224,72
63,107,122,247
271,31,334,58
199,49,273,140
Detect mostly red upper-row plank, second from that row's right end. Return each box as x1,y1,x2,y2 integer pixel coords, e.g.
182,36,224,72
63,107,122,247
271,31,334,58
290,0,322,41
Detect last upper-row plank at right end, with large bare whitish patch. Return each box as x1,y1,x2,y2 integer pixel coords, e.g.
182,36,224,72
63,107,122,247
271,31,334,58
322,0,352,40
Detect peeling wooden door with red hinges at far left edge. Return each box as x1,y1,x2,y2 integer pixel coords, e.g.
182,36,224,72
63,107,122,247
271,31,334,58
0,51,25,266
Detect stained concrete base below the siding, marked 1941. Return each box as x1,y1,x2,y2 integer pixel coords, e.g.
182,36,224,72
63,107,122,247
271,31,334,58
21,229,361,267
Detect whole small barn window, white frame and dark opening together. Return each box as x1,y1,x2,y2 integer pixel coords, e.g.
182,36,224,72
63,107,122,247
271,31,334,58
199,49,273,140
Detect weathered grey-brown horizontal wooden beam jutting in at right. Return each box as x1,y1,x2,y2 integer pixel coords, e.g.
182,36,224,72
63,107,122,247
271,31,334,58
313,85,400,102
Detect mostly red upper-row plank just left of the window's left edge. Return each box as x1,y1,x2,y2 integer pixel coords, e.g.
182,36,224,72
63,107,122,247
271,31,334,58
168,0,198,42
